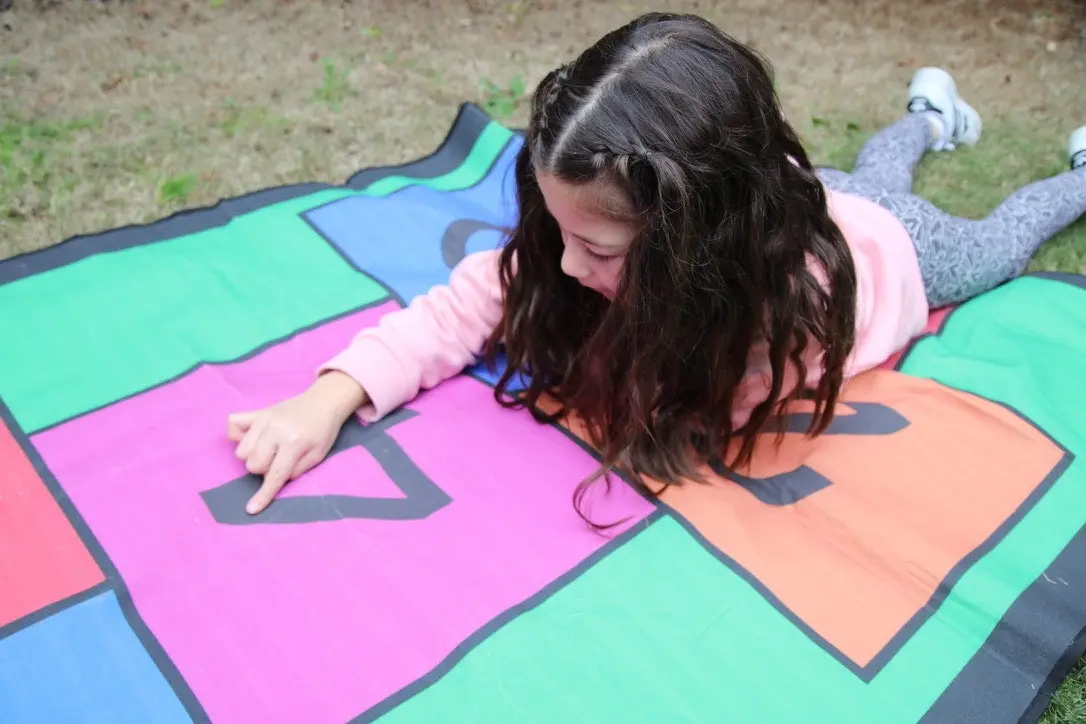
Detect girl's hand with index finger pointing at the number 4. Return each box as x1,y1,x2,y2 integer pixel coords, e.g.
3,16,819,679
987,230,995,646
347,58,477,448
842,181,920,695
227,372,368,515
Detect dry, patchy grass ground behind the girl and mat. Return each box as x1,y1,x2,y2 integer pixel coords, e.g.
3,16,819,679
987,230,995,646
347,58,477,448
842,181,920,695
0,0,1086,256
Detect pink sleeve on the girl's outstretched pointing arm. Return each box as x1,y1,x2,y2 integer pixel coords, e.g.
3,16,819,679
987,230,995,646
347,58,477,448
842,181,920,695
318,250,502,422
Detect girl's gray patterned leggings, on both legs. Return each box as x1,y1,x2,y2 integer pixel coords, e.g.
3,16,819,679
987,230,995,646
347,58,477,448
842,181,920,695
819,113,1086,307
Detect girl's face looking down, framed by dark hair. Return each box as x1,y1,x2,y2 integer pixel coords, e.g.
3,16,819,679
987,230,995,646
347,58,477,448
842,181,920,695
536,174,637,300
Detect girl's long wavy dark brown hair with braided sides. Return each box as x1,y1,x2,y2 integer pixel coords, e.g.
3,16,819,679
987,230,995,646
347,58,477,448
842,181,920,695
488,13,856,515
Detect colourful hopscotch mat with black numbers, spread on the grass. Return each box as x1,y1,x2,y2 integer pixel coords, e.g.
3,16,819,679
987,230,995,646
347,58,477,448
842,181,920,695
0,105,1086,724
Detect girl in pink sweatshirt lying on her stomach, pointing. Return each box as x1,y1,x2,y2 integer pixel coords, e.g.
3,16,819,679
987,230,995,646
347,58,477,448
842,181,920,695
228,13,1086,513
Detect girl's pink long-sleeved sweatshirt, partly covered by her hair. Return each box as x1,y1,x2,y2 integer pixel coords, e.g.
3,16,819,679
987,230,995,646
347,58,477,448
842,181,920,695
319,190,929,425
